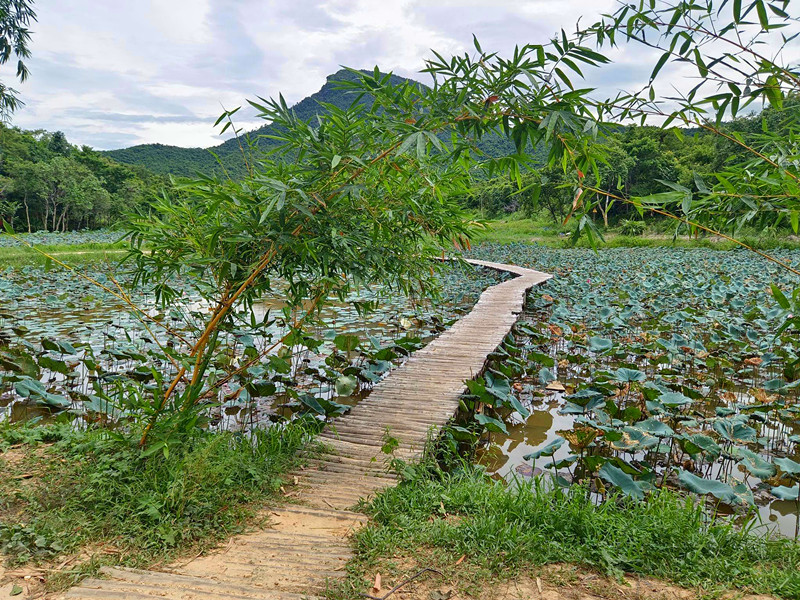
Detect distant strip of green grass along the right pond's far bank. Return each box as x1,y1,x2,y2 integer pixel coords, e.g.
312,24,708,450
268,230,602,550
476,215,800,250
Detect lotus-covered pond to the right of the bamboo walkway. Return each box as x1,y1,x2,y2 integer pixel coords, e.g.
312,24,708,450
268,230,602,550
460,245,800,536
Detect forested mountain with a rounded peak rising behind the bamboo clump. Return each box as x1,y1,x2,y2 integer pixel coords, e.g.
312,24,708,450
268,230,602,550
106,69,418,176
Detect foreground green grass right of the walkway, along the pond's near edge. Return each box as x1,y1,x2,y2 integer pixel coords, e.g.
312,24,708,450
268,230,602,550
351,466,800,599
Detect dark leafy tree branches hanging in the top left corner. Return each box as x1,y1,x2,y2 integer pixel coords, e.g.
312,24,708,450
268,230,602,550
0,0,36,121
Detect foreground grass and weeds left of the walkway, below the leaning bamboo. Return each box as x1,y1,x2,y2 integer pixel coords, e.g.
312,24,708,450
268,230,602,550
0,425,307,587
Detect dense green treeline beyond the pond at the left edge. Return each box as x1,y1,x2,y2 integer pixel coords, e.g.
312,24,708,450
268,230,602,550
0,125,165,231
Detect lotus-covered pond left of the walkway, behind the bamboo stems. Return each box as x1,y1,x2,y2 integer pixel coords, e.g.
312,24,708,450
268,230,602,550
0,264,502,429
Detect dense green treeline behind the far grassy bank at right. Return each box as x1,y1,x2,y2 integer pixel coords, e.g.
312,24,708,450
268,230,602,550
464,98,800,226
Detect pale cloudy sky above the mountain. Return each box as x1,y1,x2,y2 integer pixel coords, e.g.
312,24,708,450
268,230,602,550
0,0,792,149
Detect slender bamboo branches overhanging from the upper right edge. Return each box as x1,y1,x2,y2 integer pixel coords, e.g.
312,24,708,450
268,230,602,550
578,0,800,243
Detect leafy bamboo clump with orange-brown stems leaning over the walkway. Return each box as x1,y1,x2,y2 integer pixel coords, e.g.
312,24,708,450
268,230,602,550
129,90,482,442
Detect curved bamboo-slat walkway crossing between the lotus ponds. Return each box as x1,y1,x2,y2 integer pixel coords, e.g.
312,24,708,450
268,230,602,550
66,260,551,600
